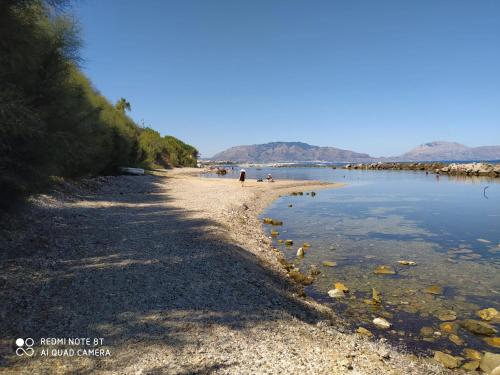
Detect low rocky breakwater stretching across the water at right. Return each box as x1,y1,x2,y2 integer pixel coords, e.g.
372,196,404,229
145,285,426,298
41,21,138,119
344,162,500,178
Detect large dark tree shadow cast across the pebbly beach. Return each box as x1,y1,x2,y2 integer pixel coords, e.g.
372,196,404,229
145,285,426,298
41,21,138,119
0,176,321,373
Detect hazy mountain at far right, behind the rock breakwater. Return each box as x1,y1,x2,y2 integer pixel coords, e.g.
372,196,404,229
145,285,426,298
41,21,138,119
397,141,500,161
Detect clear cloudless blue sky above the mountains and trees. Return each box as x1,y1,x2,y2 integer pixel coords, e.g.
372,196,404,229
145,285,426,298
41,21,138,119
74,0,500,157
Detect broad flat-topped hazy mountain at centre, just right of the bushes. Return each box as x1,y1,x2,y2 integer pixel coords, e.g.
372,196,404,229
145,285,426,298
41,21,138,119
211,142,373,163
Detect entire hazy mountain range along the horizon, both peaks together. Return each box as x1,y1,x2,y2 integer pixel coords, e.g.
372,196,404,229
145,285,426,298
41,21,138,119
211,141,500,163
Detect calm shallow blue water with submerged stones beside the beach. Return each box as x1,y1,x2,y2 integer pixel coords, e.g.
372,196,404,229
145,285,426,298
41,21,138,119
208,168,500,354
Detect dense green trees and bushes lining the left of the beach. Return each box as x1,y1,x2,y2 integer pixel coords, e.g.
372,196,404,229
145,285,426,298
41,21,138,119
0,0,197,207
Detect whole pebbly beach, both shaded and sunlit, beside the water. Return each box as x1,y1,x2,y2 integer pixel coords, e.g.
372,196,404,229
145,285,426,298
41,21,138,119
0,170,441,374
